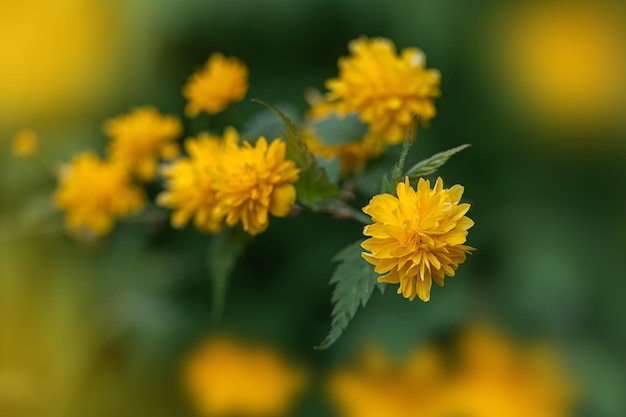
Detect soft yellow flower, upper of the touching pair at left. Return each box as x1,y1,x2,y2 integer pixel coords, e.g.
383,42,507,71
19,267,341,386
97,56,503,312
104,106,182,181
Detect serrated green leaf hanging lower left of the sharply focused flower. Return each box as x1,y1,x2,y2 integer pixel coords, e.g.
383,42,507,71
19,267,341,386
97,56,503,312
315,241,378,349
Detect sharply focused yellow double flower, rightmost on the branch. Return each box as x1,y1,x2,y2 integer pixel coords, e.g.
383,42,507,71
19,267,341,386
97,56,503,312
361,177,474,301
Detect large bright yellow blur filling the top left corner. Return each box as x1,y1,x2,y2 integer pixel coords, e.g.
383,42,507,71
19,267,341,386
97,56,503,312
0,0,122,127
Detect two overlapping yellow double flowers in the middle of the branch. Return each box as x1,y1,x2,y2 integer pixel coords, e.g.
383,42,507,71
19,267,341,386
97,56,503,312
158,128,298,235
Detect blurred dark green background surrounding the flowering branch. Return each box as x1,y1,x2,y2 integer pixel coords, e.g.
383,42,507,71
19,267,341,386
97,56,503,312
0,0,626,417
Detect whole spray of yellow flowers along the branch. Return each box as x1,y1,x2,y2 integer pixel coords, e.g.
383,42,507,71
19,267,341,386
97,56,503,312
50,38,473,310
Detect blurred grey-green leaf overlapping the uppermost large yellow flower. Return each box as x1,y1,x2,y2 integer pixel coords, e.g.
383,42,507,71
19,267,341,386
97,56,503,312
312,113,367,146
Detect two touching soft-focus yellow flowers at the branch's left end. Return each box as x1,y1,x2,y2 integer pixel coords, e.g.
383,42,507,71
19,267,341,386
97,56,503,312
55,107,182,237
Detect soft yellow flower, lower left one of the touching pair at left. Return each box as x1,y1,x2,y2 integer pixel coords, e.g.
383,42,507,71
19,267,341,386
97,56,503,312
54,153,145,236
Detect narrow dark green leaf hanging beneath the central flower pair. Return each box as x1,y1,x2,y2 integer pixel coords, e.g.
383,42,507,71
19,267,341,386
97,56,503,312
207,228,251,320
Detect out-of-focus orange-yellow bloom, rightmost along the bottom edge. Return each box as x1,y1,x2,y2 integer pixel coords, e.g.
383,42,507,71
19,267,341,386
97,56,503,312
445,327,575,417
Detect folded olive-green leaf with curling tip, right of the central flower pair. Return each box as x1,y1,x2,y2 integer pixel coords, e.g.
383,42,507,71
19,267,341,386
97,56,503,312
252,99,339,202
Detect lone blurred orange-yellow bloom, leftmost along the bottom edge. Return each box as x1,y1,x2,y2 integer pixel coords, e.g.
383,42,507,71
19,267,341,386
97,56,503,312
183,338,305,417
